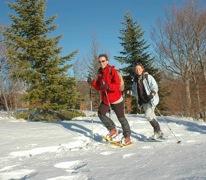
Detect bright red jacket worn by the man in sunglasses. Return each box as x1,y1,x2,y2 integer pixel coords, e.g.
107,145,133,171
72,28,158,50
91,64,122,105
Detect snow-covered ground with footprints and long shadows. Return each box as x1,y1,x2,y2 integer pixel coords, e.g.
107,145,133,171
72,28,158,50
0,113,206,180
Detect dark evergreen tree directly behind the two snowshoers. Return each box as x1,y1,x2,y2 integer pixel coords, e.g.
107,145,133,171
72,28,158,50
115,14,160,112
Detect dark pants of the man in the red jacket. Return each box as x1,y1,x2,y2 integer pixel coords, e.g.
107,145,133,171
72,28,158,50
98,101,131,137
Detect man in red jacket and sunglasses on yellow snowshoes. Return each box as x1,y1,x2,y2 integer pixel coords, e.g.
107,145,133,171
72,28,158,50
87,54,132,145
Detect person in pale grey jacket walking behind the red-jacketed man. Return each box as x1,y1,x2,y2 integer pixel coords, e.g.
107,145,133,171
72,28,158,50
132,63,163,139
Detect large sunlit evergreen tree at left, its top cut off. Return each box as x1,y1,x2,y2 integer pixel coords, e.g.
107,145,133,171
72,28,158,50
5,0,78,117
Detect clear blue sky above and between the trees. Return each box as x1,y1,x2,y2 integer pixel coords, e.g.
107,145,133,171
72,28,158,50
0,0,206,67
